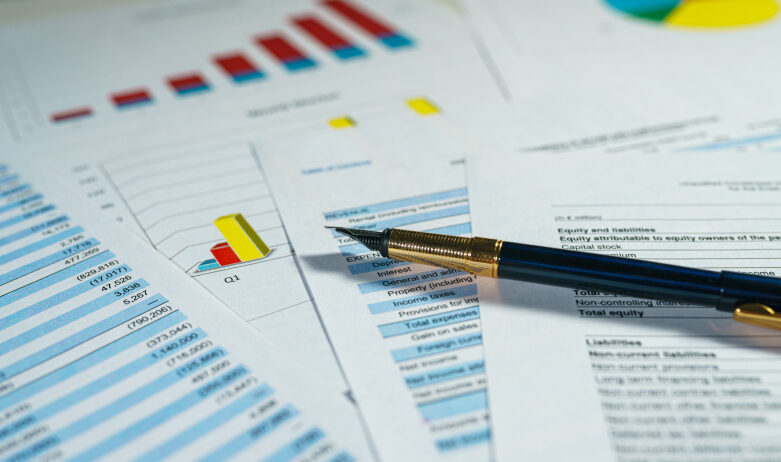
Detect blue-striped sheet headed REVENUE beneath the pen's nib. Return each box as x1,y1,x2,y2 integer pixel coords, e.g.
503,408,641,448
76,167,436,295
258,121,491,460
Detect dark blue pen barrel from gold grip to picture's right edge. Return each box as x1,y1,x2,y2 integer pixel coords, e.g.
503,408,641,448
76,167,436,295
498,242,781,312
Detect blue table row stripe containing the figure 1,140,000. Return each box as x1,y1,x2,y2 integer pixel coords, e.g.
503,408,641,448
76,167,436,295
0,329,206,440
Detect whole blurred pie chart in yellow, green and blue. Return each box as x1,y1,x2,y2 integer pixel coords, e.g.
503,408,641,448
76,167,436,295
605,0,778,28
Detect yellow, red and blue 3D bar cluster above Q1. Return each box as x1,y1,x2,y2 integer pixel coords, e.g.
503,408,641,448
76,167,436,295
198,213,271,271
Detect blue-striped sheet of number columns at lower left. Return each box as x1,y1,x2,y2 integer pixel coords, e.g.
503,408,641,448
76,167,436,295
0,163,371,461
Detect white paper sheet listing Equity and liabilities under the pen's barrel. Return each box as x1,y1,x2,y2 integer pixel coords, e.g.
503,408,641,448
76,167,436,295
467,151,781,461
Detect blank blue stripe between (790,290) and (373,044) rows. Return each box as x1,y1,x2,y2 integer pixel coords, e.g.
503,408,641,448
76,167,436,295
0,311,187,409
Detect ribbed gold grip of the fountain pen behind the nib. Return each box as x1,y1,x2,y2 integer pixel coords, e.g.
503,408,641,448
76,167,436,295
388,229,502,278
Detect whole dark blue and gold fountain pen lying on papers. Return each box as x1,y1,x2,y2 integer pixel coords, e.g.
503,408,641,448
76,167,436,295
329,227,781,329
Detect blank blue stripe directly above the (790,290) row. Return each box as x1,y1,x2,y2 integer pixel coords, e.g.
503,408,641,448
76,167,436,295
0,294,166,379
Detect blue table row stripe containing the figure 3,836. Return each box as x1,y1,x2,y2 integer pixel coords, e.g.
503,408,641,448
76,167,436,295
0,279,149,355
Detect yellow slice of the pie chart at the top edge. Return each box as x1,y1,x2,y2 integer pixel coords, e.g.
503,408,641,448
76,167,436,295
664,0,778,27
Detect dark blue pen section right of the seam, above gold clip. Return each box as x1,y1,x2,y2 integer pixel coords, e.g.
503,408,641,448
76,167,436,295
717,271,781,312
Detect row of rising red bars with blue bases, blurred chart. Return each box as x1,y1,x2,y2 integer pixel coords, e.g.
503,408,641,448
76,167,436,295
48,0,414,124
